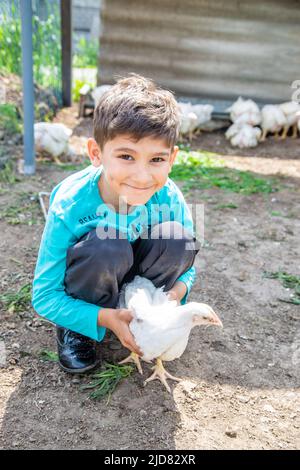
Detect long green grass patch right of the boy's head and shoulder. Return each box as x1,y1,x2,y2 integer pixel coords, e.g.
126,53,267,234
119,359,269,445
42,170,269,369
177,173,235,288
170,150,278,194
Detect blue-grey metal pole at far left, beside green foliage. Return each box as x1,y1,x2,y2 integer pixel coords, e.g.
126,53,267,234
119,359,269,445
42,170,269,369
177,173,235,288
20,0,35,175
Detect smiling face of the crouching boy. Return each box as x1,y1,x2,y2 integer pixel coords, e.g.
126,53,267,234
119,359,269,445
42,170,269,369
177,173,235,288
88,135,178,210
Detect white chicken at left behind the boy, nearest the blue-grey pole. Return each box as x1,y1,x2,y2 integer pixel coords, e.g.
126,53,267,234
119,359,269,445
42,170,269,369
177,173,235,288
34,122,73,165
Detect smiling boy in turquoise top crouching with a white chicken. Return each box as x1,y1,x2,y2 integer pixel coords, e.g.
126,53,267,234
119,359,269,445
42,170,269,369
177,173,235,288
32,74,199,373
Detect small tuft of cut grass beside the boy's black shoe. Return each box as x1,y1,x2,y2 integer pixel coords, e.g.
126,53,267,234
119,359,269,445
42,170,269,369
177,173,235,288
81,363,133,403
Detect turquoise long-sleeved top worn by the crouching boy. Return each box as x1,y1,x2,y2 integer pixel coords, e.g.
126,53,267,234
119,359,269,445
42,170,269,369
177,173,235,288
32,165,195,341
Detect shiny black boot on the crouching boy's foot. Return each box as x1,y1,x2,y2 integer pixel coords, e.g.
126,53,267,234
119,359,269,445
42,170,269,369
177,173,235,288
56,326,99,374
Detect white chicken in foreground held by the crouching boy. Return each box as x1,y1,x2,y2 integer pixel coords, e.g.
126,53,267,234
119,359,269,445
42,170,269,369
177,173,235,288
119,276,222,392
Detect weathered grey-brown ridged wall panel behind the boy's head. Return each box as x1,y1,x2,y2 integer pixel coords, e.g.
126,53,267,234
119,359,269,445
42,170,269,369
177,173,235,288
98,0,300,102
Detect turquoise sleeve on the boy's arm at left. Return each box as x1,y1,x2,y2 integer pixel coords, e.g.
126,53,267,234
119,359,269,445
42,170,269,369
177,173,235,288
32,209,105,341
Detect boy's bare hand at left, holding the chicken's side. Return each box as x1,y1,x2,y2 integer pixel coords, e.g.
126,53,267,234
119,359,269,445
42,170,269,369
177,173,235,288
98,308,143,356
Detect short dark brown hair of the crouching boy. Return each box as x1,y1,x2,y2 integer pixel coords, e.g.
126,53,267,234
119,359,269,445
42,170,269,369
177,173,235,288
94,73,180,150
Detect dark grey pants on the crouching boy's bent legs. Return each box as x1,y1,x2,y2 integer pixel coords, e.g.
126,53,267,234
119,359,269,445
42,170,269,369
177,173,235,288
65,222,199,308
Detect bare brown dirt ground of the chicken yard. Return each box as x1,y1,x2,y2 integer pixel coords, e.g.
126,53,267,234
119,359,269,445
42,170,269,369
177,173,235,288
0,110,300,450
